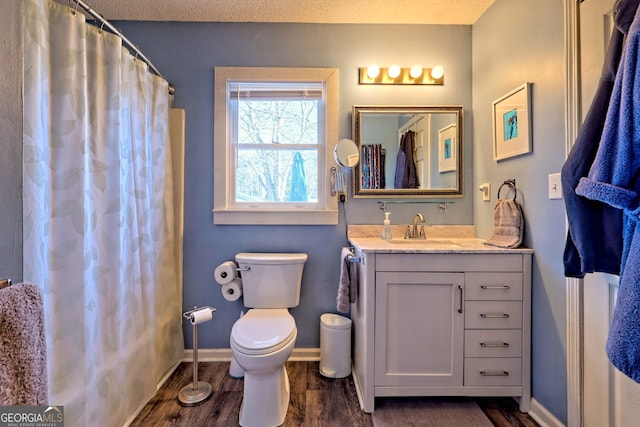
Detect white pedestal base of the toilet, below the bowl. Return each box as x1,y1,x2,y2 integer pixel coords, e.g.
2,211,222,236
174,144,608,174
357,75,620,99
240,365,290,427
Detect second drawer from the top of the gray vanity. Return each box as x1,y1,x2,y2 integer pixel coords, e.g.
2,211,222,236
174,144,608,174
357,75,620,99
464,301,522,329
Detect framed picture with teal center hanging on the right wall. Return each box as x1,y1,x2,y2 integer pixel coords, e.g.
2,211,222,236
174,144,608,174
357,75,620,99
492,83,532,161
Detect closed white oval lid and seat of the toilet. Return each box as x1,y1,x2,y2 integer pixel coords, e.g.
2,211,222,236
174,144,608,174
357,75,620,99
231,308,296,354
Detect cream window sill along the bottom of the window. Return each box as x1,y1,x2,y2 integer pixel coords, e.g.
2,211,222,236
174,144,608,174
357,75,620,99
213,209,338,225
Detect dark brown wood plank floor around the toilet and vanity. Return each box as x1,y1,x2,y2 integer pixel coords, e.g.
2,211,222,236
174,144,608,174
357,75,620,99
131,362,539,427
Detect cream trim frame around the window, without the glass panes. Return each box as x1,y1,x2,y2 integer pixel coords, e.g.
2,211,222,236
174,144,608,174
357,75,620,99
213,67,338,225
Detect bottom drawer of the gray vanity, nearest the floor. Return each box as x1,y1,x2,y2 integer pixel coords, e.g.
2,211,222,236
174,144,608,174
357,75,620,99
464,357,522,386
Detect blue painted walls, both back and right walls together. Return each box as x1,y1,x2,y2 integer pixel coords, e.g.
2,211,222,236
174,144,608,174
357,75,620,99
117,5,567,422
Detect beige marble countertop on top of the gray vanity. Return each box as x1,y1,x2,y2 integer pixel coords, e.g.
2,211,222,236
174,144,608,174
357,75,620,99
348,225,533,254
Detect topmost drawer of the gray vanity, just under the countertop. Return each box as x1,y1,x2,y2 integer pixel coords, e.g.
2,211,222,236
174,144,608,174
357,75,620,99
464,272,522,301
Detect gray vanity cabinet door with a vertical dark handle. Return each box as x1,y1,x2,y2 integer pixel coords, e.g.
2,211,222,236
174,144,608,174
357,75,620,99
374,272,464,388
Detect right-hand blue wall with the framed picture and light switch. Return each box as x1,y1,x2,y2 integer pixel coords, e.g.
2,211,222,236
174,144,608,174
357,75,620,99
473,0,567,423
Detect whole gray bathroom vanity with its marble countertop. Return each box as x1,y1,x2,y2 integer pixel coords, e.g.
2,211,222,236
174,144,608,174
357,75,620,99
349,229,533,412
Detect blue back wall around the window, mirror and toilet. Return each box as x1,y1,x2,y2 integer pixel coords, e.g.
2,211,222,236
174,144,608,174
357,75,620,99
116,21,473,348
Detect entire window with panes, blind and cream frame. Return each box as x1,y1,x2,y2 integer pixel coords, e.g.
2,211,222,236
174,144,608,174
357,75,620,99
214,67,338,224
